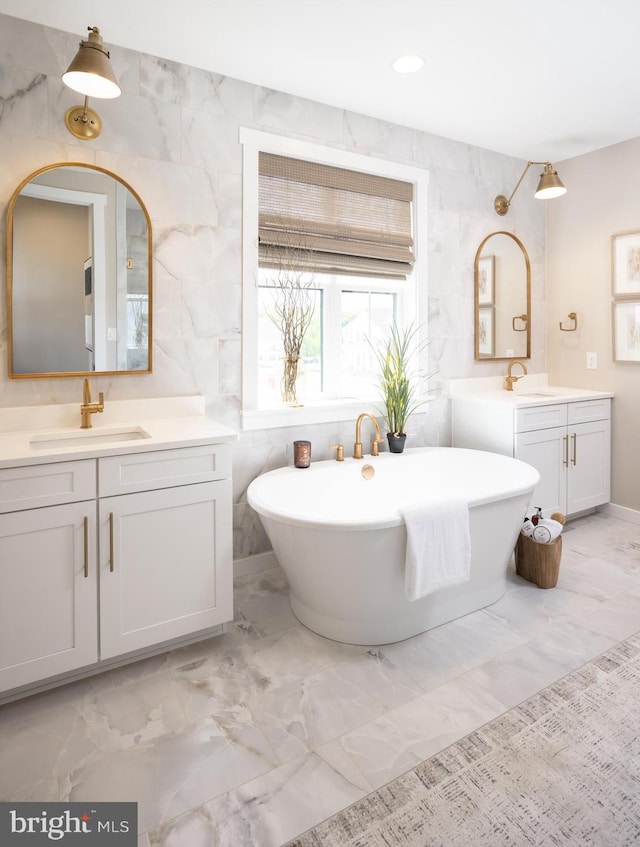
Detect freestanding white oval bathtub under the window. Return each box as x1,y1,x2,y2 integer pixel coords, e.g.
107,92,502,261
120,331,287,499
247,447,540,644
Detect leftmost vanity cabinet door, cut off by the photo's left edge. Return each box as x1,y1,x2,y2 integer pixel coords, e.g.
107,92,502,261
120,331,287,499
0,501,98,690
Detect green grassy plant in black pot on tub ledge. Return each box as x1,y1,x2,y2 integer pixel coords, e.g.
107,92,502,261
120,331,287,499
373,323,426,453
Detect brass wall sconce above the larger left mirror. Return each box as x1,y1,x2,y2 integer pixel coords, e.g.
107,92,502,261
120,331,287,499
62,26,121,141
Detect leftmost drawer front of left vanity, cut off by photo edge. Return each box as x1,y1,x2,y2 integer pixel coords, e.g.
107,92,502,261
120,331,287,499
0,459,96,514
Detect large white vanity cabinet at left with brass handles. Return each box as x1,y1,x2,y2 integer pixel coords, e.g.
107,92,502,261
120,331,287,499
0,444,233,692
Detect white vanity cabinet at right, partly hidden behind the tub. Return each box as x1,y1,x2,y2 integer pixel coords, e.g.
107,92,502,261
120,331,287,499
452,397,611,515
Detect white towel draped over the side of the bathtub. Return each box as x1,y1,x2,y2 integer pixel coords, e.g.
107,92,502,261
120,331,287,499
399,498,471,600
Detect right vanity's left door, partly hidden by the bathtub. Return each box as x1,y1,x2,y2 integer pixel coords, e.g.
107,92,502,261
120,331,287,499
514,426,568,514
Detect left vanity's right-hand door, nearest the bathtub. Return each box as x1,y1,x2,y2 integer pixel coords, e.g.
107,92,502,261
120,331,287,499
99,479,233,659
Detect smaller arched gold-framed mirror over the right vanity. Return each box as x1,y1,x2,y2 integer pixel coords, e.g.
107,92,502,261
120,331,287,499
474,232,531,362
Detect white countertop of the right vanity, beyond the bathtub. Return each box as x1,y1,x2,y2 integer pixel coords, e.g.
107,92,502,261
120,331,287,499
449,370,614,408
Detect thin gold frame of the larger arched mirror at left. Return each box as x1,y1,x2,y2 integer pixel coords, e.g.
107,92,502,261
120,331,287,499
6,162,153,379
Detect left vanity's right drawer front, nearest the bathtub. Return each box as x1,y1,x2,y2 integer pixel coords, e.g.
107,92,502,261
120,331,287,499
98,444,231,497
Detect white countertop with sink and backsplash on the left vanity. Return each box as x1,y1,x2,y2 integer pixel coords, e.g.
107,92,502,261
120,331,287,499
0,397,238,468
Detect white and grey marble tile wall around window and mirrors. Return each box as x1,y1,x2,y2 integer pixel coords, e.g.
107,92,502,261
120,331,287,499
0,15,546,558
